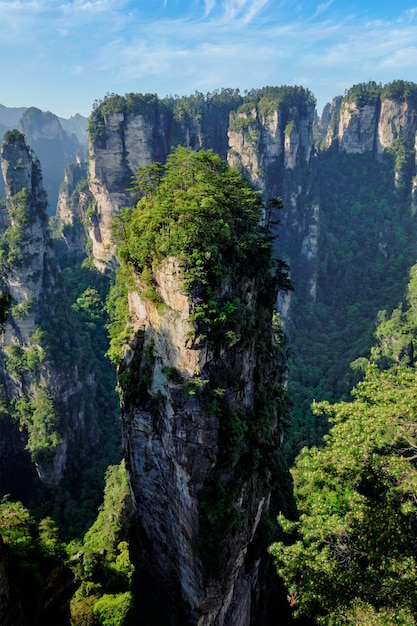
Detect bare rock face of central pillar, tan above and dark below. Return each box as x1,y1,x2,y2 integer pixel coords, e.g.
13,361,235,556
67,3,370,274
119,258,280,626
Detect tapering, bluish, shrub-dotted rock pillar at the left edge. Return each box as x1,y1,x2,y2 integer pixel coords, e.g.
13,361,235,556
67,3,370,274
0,131,95,492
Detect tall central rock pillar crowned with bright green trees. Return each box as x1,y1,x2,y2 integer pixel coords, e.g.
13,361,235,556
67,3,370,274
113,150,287,626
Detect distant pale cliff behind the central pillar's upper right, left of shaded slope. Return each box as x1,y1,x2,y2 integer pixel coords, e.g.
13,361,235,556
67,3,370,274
228,87,320,319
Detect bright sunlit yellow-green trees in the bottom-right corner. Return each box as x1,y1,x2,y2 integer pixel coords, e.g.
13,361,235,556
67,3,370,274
271,267,417,625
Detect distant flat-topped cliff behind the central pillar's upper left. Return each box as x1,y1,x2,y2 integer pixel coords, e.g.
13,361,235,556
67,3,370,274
65,89,242,272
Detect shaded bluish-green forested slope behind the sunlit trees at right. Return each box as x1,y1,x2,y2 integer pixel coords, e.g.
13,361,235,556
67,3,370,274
281,149,417,458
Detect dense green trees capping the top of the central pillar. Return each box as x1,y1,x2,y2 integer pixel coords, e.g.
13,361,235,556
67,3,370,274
111,147,289,358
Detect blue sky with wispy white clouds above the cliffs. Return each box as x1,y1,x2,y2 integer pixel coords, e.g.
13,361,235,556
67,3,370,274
0,0,417,117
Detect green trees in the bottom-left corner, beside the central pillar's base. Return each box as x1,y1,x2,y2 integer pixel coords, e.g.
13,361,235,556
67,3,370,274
0,462,134,626
